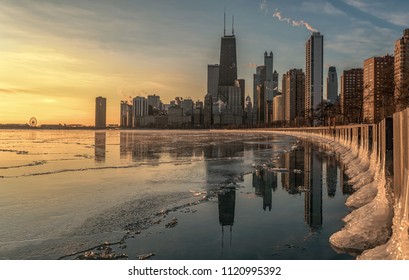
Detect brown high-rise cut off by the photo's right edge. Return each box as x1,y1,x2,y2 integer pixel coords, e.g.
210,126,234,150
394,29,409,111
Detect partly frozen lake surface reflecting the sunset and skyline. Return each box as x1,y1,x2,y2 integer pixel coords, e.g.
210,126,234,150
0,130,352,259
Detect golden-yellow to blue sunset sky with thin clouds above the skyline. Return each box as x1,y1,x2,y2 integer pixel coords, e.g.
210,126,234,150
0,0,409,125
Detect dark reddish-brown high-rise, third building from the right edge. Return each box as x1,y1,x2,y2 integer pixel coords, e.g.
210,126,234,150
340,68,364,124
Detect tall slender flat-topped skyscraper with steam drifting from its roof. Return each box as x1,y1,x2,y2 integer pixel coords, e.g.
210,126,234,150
305,32,324,123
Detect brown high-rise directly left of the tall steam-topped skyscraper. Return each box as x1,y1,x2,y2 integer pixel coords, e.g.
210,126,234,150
282,69,305,125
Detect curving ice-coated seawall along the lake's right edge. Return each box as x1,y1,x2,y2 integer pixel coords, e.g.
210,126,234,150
274,106,409,259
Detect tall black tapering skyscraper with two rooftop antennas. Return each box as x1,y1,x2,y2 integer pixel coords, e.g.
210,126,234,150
218,14,237,102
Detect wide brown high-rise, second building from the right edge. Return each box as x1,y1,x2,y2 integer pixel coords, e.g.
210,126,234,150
363,55,394,123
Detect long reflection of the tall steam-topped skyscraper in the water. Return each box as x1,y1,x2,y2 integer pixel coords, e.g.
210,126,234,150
304,142,322,229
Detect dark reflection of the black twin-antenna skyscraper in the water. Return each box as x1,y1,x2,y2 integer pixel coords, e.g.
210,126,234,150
217,187,236,248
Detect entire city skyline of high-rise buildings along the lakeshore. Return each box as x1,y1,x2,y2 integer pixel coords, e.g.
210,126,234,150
103,26,409,128
